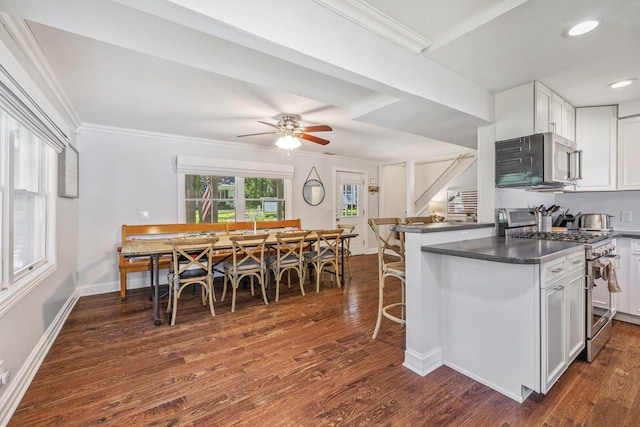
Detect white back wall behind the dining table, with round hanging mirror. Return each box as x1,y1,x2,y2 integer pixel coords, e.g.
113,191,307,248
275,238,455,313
78,126,378,295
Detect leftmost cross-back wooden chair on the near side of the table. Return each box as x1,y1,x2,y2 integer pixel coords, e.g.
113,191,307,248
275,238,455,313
167,236,218,325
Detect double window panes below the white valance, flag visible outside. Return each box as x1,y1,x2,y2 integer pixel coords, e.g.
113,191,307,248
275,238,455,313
184,175,286,223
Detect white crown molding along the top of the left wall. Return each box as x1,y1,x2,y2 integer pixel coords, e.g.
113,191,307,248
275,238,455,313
0,12,80,128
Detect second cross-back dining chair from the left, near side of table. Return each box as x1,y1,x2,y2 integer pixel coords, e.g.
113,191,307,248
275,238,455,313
221,234,269,312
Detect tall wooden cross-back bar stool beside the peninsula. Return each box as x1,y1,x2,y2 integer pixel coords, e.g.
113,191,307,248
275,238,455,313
369,218,406,339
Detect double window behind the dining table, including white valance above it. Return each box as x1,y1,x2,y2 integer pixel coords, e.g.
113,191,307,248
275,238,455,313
177,156,293,223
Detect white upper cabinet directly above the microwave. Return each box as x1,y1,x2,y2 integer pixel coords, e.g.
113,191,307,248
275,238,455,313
495,82,575,141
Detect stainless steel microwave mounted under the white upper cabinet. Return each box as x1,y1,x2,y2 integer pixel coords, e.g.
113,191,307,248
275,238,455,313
495,132,582,189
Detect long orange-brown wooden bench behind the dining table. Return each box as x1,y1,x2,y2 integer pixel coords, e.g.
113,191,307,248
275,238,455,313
118,219,301,300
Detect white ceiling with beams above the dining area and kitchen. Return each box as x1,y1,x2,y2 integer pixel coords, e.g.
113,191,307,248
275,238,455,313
0,0,640,162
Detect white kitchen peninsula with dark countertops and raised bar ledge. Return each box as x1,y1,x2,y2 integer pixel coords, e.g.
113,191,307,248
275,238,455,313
397,223,585,402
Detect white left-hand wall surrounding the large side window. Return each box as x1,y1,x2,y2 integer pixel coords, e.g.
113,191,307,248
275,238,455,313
0,28,78,418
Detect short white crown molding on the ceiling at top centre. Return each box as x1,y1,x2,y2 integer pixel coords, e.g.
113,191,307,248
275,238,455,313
314,0,431,54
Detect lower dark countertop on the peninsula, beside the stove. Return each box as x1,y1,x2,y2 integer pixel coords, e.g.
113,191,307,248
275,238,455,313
421,237,584,264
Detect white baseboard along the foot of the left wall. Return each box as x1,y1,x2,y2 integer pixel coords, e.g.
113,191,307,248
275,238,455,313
0,291,79,426
